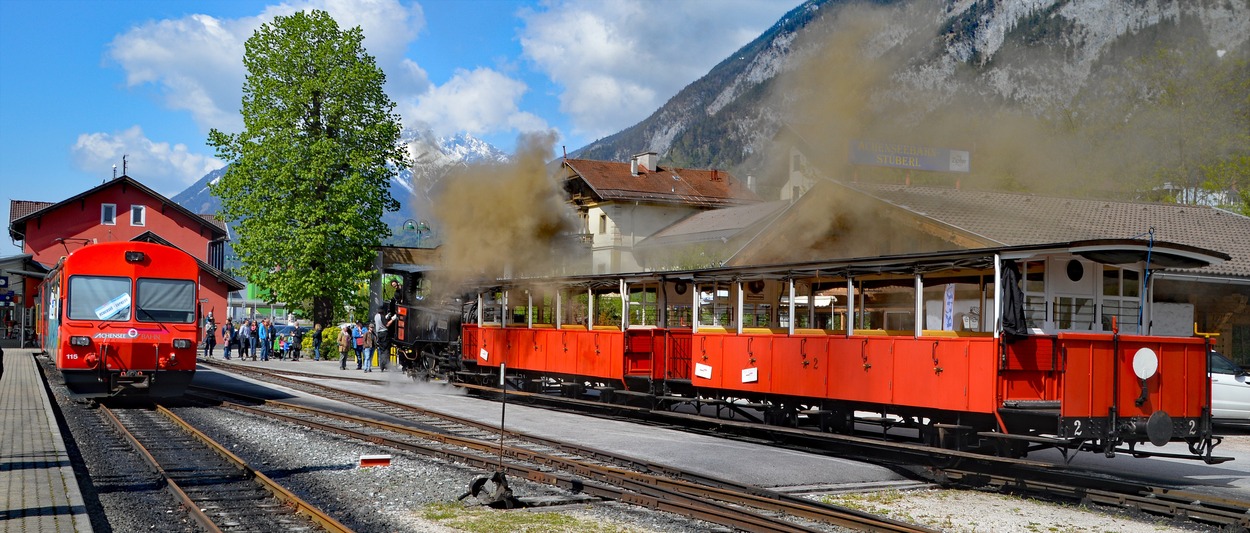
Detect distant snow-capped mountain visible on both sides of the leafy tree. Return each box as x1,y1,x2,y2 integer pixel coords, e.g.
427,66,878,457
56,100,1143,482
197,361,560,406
171,130,509,246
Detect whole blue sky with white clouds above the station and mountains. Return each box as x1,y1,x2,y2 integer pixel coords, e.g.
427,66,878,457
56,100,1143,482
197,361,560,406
0,0,800,256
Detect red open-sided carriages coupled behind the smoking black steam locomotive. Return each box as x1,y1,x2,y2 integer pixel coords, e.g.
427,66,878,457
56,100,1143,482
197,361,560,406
460,240,1228,462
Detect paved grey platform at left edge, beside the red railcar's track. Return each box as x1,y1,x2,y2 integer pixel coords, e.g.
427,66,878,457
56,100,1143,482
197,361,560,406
0,348,93,533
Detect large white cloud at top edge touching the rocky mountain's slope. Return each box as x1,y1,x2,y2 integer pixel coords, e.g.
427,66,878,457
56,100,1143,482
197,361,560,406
520,0,795,138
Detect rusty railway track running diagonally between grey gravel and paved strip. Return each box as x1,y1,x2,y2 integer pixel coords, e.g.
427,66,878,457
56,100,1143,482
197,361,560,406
197,360,930,532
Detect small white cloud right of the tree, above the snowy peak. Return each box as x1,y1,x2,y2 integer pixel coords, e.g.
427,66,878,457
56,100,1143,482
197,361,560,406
401,68,548,135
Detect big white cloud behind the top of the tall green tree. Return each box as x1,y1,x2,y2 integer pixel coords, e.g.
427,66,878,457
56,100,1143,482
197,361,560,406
109,0,429,131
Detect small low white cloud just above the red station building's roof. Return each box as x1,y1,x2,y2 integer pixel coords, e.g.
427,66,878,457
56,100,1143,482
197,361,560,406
70,126,225,195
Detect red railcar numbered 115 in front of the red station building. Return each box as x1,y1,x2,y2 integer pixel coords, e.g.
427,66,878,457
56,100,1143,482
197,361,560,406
39,241,200,398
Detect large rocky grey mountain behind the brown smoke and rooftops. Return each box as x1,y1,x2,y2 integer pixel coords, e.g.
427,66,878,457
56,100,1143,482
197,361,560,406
570,0,1250,201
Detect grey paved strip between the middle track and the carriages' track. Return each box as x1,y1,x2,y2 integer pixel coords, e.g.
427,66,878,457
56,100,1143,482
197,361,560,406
195,357,923,493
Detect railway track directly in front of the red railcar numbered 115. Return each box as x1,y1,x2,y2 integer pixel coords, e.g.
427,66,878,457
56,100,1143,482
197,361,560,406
100,405,350,532
